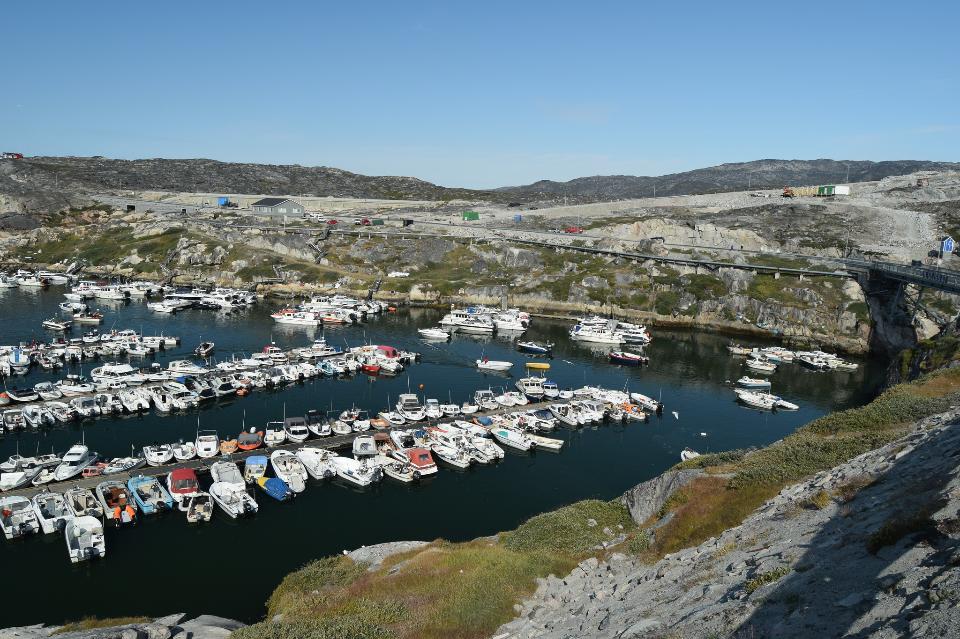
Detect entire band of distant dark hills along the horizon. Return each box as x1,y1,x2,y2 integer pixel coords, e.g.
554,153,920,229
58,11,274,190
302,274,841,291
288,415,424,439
0,157,960,212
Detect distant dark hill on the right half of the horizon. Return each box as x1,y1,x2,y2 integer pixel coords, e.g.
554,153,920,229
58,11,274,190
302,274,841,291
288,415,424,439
500,160,960,202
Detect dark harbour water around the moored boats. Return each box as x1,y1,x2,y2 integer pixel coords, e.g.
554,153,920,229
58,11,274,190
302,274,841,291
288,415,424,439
0,287,882,626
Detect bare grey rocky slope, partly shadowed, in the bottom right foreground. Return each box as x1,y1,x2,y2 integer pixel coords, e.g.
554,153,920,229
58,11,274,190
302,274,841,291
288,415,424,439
495,409,960,639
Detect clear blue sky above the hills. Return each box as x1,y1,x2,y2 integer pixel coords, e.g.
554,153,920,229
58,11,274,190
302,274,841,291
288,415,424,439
0,0,960,188
